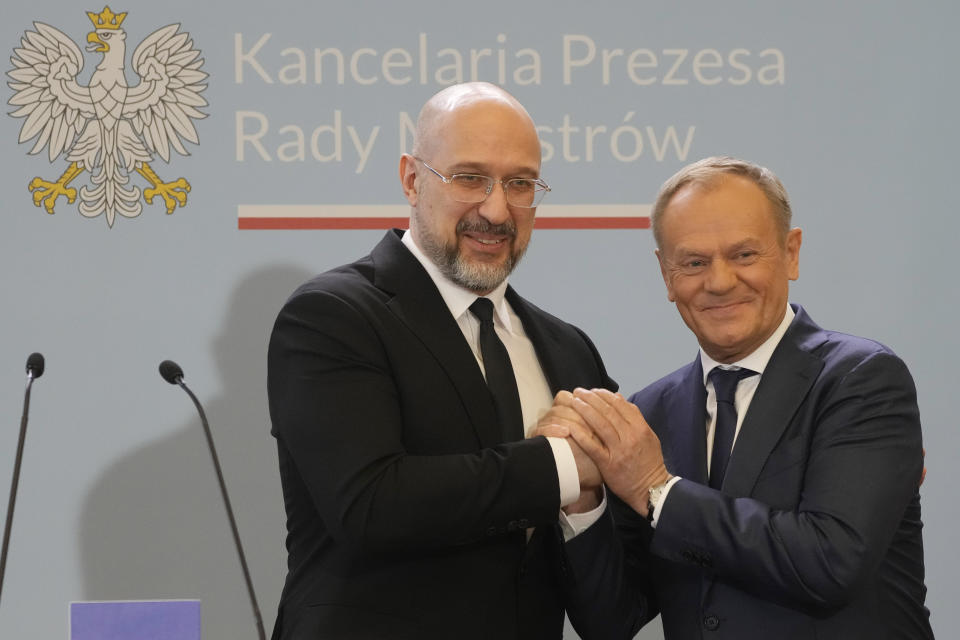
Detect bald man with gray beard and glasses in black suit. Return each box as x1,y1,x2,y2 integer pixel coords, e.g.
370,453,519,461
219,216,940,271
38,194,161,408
268,83,616,640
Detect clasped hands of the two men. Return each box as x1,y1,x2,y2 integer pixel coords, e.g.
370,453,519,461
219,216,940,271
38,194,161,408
534,388,671,516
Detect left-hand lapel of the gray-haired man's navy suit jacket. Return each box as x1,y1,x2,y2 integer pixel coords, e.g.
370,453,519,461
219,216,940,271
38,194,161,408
660,354,707,484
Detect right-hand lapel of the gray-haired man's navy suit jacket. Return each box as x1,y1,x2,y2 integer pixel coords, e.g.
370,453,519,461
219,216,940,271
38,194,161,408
722,307,823,496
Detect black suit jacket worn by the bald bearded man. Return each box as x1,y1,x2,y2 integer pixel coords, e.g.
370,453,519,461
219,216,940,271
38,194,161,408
268,231,615,640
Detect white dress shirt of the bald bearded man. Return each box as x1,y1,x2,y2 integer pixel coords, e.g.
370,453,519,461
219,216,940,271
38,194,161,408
403,231,580,507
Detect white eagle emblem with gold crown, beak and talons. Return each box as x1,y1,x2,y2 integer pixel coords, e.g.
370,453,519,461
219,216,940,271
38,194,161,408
7,6,207,227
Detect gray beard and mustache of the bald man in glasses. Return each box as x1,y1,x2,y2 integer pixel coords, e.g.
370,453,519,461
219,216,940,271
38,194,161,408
420,220,526,293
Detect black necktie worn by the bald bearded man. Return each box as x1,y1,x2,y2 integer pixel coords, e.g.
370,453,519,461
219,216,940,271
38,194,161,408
470,298,523,441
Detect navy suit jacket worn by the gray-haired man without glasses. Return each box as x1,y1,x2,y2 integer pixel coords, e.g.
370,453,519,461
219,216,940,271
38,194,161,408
567,307,933,640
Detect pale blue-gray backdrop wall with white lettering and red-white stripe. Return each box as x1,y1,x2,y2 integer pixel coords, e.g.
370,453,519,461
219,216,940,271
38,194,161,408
0,0,960,639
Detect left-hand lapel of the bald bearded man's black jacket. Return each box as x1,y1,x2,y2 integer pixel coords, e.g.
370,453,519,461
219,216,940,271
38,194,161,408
370,230,503,447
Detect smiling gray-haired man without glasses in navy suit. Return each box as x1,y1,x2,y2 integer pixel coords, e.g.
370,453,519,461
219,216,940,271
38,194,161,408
552,158,933,640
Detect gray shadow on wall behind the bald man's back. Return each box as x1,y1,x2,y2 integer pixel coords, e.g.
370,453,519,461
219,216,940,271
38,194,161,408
80,267,312,640
